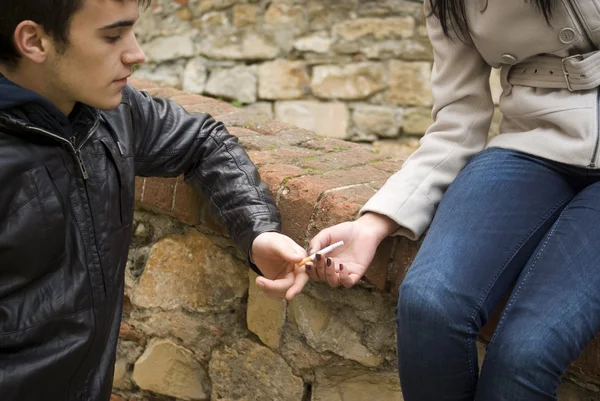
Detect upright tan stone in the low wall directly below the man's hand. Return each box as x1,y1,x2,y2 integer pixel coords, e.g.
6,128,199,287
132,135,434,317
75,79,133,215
247,272,286,348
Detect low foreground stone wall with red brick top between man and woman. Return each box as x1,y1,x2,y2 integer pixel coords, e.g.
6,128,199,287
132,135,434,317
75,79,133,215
113,76,600,401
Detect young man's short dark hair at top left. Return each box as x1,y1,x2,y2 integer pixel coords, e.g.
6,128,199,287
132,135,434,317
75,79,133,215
0,0,152,67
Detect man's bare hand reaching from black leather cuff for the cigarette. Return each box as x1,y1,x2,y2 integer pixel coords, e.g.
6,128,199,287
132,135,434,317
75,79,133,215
252,232,309,301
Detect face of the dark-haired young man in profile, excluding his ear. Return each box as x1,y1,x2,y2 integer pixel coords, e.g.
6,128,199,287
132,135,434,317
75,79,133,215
46,0,145,110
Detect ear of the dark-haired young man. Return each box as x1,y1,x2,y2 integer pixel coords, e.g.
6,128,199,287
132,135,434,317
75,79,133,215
13,20,54,64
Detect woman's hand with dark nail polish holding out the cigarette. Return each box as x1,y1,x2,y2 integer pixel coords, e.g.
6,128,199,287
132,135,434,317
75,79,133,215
306,213,398,288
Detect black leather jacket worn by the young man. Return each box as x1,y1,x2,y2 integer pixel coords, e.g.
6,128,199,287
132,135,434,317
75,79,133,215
0,83,280,401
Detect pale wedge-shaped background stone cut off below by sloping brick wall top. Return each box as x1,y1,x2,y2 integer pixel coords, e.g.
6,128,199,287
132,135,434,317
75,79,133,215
275,101,350,139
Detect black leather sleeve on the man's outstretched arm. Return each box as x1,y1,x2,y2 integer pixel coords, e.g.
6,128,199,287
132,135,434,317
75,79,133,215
126,87,281,273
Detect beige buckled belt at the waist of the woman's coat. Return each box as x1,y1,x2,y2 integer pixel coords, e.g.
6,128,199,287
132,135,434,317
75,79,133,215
508,51,600,92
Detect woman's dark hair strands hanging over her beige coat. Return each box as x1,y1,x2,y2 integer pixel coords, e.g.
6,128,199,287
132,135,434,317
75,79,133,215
429,0,556,37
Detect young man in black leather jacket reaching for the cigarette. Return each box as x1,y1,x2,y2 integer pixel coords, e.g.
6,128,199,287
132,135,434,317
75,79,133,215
0,0,307,401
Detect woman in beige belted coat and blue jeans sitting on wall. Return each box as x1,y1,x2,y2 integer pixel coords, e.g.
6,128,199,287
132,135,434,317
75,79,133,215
262,0,600,401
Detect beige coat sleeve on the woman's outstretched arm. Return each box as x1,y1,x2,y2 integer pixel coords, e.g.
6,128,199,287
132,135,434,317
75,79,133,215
360,4,494,240
